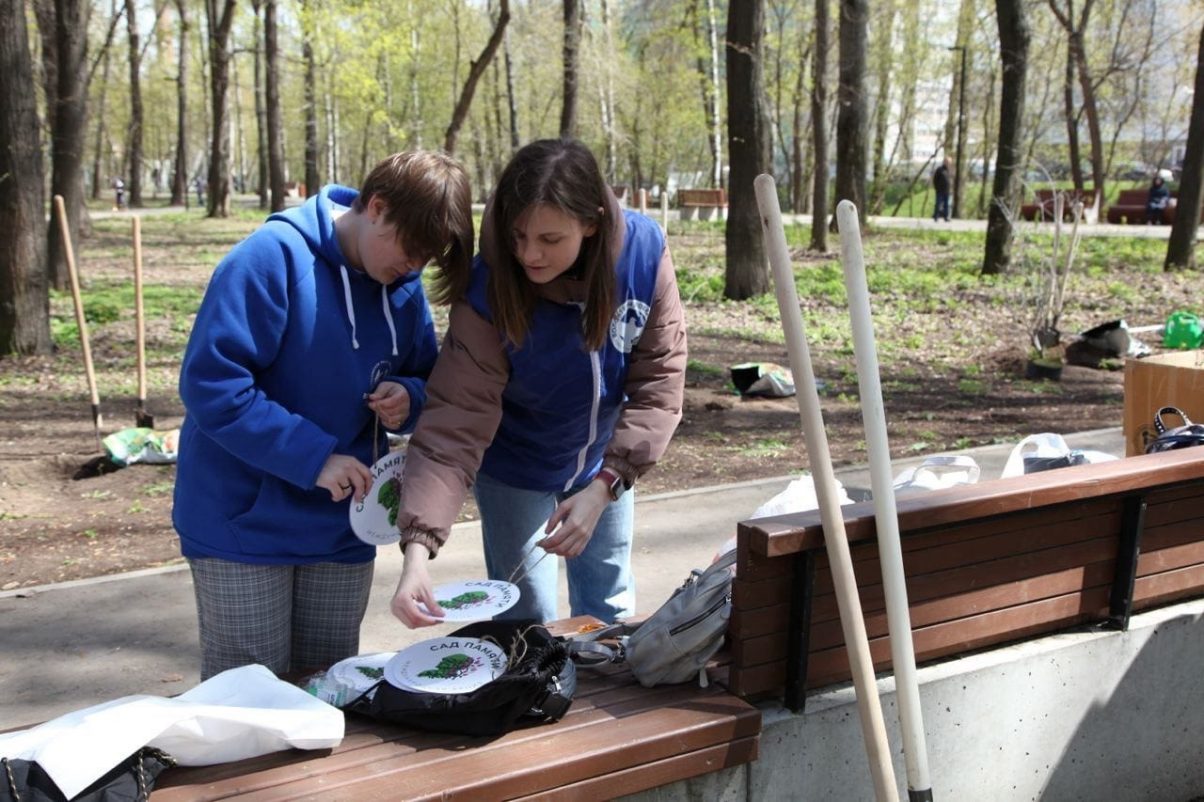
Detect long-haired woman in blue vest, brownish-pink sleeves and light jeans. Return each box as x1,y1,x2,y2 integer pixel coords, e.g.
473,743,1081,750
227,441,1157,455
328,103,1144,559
393,140,686,626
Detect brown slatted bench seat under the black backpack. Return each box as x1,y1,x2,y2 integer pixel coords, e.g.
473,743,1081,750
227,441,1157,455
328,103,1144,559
153,619,761,802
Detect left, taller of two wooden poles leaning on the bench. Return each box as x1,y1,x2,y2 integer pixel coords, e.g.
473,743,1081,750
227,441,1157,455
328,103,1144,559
753,175,898,802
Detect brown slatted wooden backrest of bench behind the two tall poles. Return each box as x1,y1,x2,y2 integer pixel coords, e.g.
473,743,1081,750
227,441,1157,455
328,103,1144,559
728,448,1204,710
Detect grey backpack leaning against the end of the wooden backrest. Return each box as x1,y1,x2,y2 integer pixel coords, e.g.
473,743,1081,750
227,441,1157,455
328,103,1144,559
569,549,736,688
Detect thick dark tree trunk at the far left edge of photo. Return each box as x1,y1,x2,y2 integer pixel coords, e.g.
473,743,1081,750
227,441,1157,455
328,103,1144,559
0,0,53,351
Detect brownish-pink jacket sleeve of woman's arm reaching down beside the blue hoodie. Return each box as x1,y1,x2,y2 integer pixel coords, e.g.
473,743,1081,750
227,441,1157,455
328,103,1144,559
397,302,510,556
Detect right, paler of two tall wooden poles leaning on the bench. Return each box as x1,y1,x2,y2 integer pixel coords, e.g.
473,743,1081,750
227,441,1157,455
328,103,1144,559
836,200,932,802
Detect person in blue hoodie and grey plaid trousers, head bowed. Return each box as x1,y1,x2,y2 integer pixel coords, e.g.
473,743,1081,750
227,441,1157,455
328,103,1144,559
172,152,473,679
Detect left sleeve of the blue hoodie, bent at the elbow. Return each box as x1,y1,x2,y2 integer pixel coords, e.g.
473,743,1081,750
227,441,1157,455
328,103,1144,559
179,235,337,489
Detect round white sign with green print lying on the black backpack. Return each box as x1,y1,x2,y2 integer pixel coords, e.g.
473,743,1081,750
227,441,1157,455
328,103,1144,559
384,638,506,694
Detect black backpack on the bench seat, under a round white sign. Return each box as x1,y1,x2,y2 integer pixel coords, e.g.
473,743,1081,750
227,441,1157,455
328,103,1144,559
343,620,577,736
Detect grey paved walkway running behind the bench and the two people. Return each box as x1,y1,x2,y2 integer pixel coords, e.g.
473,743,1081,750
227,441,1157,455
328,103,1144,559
0,429,1125,730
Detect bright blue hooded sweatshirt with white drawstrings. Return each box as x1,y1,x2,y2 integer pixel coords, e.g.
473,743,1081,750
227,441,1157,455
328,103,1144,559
172,185,437,565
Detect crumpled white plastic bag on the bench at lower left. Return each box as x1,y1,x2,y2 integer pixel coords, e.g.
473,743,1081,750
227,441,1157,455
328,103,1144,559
0,666,343,798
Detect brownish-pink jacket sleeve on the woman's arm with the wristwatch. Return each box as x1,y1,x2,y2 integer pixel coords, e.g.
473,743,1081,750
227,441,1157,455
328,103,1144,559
602,246,686,485
